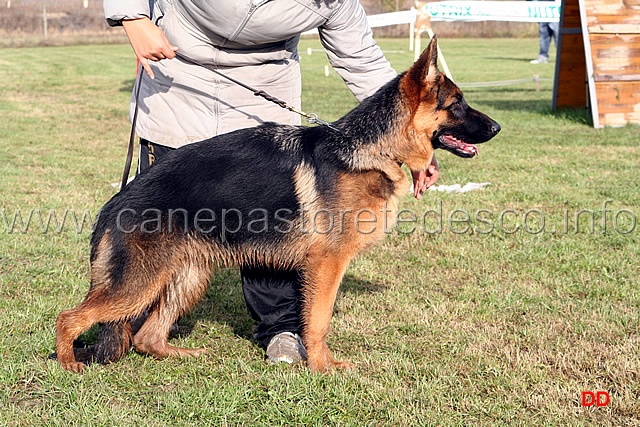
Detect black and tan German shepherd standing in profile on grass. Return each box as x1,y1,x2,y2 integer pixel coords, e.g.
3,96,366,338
56,37,500,372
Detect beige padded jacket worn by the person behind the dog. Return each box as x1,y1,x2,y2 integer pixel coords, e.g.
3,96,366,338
104,0,396,147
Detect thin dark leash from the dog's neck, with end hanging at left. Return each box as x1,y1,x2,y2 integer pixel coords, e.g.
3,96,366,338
120,54,342,189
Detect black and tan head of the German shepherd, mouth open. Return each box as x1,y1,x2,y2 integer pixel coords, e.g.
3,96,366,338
401,36,500,170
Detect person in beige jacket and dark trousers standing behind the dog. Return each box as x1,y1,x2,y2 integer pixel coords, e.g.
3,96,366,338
99,0,439,363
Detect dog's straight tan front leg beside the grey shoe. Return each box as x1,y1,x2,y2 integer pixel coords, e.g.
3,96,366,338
302,253,353,372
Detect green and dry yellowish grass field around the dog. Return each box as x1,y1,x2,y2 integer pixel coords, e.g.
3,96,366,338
0,39,640,426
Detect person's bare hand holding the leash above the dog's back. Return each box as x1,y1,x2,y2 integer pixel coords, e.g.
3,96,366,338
122,18,178,79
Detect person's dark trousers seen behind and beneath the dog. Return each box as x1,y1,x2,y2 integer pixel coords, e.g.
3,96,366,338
138,139,302,348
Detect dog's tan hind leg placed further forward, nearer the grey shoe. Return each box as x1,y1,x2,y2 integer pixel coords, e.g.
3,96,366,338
133,262,211,359
